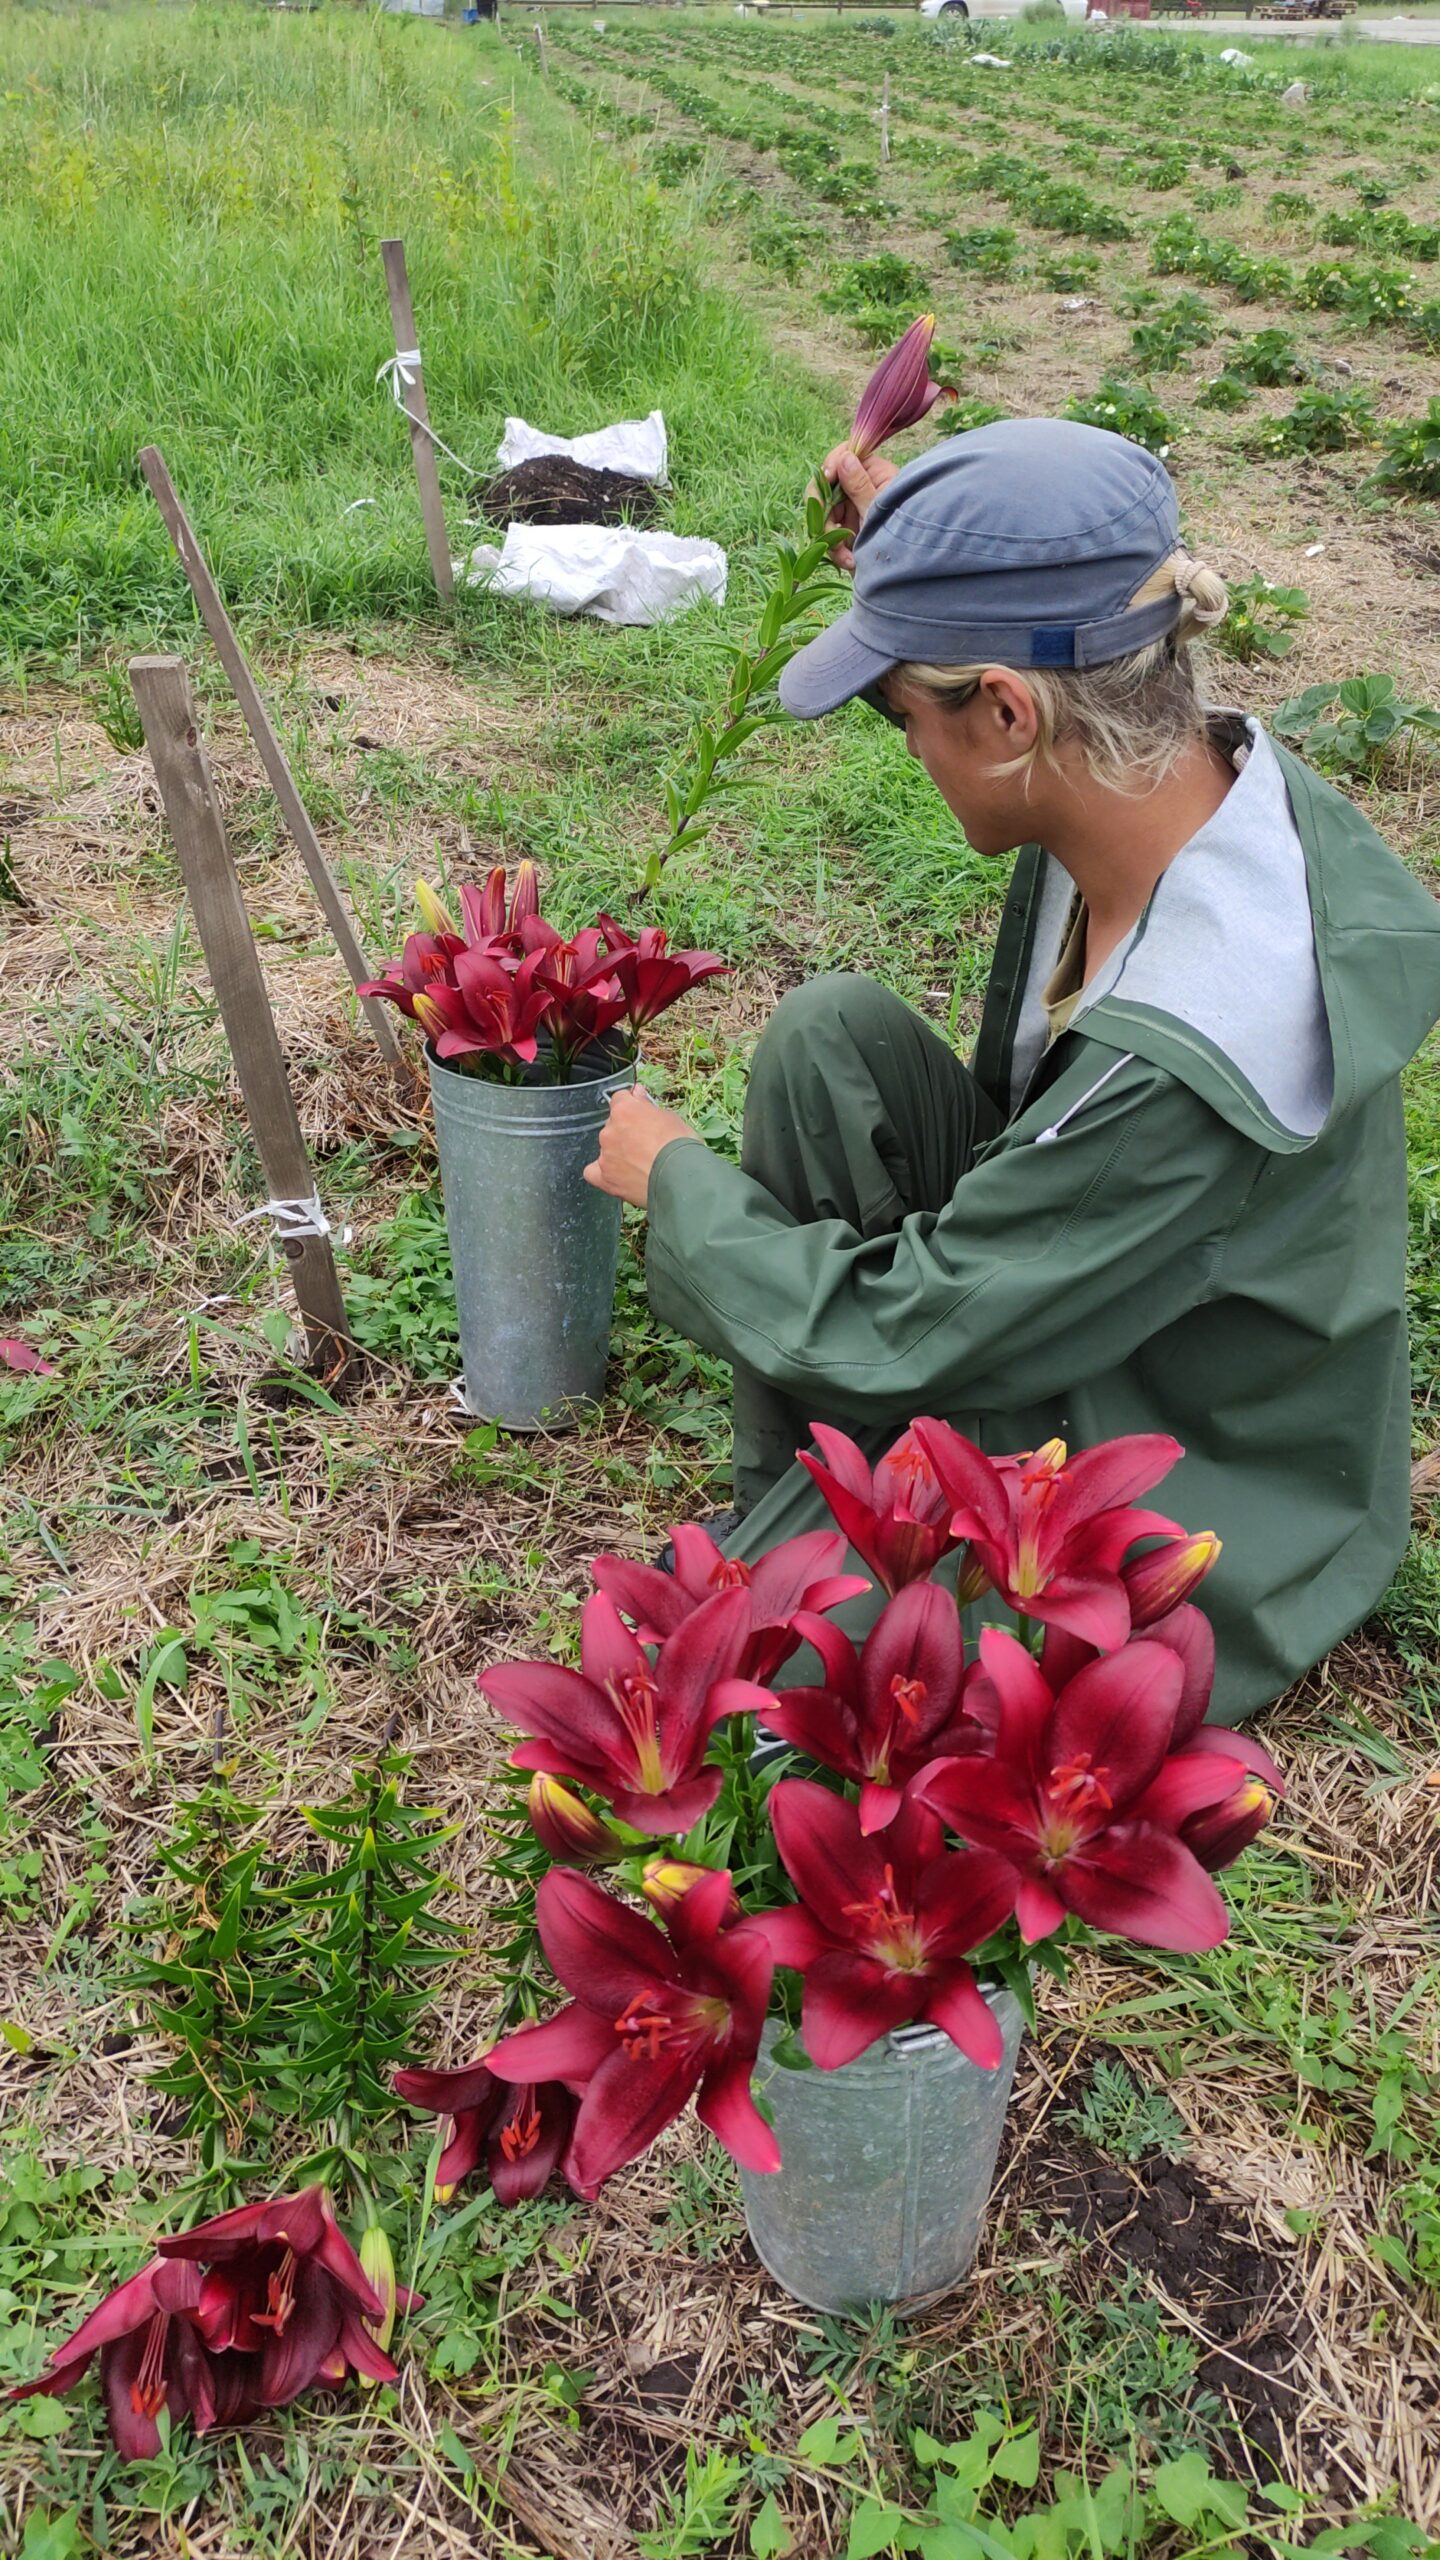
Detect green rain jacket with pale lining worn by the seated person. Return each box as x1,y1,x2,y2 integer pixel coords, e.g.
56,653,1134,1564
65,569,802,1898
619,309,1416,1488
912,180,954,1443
646,724,1440,1723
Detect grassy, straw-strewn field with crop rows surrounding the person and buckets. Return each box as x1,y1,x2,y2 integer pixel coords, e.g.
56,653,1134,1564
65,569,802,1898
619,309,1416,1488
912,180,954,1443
0,15,1440,2560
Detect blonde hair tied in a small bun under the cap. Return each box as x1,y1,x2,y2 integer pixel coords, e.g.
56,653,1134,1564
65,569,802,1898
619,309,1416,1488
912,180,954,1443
894,550,1230,794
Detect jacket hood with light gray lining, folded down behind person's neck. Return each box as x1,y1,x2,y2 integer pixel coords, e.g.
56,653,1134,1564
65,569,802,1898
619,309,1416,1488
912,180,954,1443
1015,714,1440,1155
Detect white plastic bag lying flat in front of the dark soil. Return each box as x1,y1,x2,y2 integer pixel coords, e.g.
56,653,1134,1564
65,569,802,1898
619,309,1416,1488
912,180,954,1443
456,524,728,622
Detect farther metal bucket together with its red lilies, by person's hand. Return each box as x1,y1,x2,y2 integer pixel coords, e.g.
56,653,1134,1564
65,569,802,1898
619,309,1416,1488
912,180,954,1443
361,863,725,1431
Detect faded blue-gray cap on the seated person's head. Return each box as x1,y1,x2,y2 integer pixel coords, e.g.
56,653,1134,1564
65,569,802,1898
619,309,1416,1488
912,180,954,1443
779,417,1184,719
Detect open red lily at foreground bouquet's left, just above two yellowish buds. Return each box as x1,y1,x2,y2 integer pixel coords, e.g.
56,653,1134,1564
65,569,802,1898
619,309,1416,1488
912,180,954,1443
479,1592,769,1838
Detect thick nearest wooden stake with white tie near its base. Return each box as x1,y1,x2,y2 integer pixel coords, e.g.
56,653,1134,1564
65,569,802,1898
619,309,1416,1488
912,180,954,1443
131,658,356,1385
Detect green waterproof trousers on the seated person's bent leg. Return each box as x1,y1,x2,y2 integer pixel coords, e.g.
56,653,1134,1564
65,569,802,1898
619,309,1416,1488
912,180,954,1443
735,975,1002,1515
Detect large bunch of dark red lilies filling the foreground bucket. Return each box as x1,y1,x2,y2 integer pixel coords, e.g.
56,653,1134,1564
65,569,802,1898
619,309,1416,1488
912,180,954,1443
397,1421,1281,2202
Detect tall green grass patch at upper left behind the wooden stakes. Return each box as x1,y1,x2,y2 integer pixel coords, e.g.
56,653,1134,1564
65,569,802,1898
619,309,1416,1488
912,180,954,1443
0,5,820,666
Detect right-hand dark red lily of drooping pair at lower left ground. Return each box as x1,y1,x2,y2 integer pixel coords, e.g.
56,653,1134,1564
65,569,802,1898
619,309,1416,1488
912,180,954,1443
156,2186,400,2409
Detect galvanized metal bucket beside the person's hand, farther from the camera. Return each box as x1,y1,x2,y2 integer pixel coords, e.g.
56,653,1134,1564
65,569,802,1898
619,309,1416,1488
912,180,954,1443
425,1050,635,1431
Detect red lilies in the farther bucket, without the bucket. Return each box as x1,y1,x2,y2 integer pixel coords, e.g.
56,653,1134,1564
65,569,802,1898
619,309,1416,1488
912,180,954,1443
361,863,725,1085
